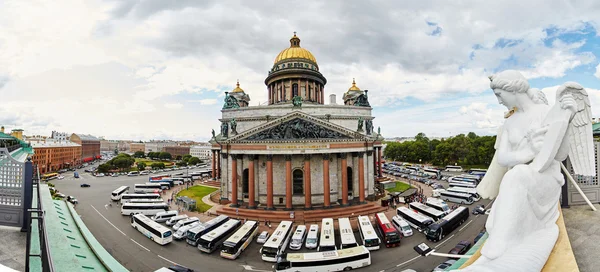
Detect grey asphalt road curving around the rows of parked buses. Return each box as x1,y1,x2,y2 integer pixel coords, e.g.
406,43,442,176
51,169,489,272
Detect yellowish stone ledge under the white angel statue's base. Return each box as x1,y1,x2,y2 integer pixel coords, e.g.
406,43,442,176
460,208,579,272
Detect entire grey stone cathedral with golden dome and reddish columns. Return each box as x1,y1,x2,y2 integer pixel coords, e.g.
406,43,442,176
210,34,383,210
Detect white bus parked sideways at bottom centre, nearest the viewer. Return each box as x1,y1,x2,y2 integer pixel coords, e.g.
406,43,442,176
275,246,371,272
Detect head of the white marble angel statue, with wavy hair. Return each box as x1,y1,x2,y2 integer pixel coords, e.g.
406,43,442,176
490,70,529,109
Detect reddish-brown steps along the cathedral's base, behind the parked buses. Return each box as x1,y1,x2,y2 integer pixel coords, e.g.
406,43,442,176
217,203,386,223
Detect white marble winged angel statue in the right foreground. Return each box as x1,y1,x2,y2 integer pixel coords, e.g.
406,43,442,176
460,70,596,272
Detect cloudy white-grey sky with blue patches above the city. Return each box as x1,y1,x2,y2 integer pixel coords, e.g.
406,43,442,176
0,0,600,141
